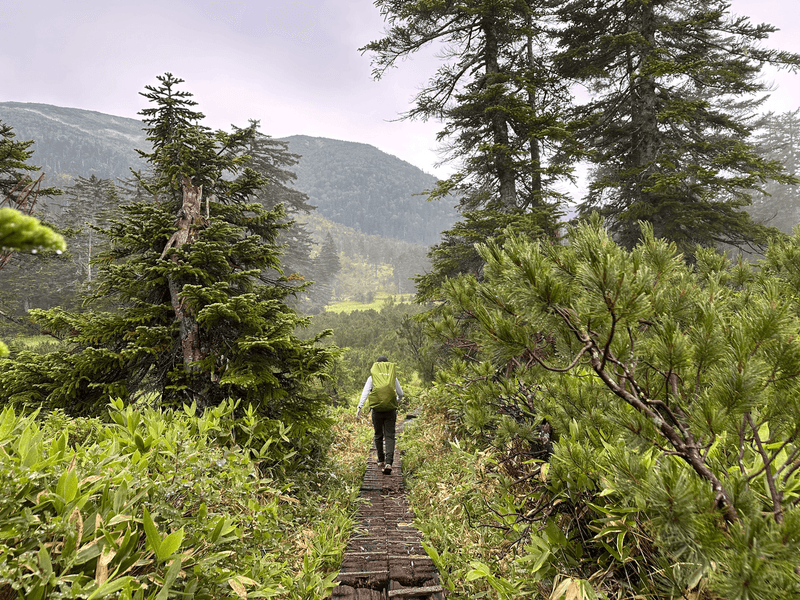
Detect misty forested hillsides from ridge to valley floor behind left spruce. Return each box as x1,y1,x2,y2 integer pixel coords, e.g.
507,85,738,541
0,102,446,316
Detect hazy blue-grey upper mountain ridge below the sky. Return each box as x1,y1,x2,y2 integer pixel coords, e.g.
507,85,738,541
0,102,457,245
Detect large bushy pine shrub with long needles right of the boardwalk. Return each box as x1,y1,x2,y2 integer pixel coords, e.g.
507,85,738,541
418,219,800,600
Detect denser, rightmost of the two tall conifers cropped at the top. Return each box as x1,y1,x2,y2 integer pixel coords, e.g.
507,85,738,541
556,0,800,253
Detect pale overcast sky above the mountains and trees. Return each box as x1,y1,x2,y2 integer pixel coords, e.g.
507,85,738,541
0,0,800,176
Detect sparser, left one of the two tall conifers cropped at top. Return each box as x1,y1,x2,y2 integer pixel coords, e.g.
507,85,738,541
362,0,573,296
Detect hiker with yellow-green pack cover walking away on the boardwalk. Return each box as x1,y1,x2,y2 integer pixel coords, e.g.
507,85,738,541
356,356,403,475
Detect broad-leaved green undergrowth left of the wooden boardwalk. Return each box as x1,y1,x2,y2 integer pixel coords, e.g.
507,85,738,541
0,402,368,600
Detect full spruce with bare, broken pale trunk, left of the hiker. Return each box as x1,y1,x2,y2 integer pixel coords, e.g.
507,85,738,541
0,73,332,420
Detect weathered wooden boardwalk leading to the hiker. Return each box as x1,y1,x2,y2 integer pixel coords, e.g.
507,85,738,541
331,422,445,600
